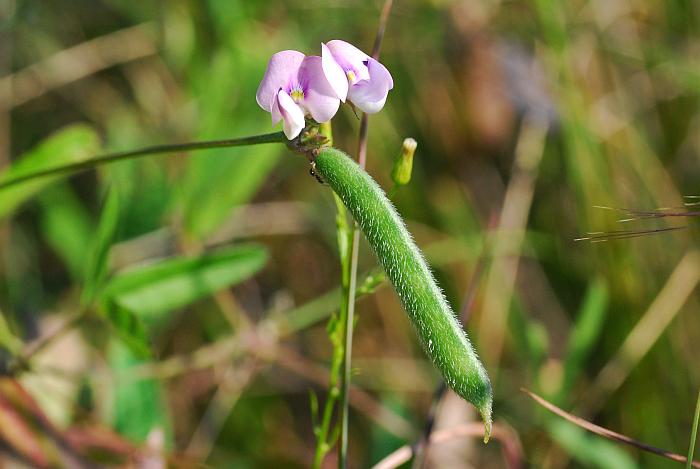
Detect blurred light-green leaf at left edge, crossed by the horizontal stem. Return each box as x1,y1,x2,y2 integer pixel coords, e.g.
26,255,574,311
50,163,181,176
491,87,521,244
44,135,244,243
0,125,100,218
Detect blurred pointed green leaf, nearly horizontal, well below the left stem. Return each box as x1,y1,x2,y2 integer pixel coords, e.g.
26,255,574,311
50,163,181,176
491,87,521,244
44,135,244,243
103,245,267,323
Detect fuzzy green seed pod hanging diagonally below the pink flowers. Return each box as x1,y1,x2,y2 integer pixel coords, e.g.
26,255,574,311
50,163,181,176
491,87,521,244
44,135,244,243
315,148,493,441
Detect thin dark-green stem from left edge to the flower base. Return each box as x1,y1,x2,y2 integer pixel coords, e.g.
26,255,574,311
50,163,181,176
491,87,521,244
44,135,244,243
0,132,287,189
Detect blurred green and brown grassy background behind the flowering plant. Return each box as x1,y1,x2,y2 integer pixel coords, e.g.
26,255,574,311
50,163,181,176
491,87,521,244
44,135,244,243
0,0,700,468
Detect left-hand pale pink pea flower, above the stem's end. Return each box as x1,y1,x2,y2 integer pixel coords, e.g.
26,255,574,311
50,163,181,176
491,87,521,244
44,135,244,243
255,50,340,140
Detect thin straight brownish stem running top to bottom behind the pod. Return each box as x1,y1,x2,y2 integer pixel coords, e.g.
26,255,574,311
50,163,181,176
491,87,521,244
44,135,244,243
338,0,394,469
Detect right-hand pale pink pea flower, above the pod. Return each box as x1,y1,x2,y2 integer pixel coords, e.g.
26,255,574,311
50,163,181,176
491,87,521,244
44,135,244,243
321,39,394,114
